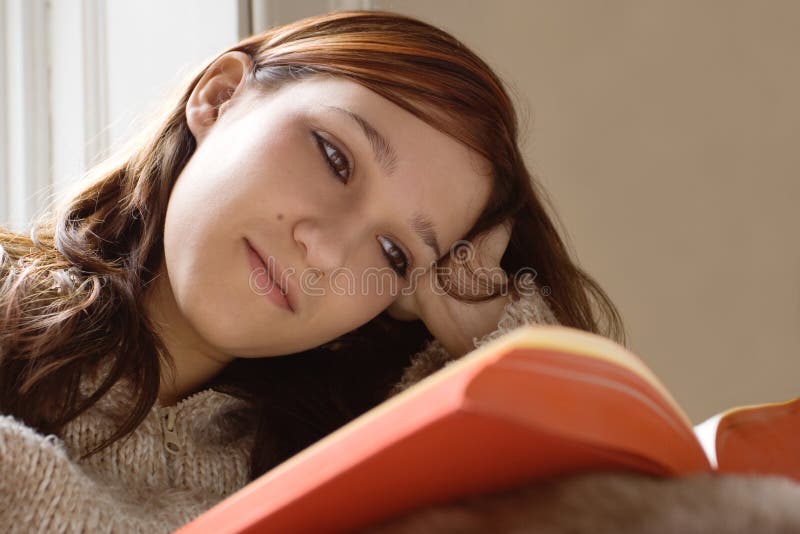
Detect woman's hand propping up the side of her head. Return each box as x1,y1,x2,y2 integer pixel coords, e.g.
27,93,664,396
387,221,512,357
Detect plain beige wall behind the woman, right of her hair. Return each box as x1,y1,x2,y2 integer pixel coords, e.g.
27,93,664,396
374,0,800,428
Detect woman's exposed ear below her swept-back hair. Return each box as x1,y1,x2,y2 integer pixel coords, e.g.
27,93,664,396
186,50,253,144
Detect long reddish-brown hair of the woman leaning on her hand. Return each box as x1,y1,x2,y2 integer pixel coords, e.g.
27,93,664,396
0,11,625,477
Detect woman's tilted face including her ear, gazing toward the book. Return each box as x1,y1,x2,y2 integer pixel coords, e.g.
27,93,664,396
164,54,491,357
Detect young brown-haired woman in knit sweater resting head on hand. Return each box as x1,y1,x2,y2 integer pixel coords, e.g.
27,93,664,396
0,11,624,532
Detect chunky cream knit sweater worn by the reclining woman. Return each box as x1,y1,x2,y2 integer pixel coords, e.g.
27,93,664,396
0,291,557,534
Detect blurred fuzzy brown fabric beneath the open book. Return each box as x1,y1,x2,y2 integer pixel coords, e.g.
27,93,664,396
361,472,800,534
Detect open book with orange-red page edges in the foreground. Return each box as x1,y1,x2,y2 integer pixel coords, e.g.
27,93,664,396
177,325,800,534
